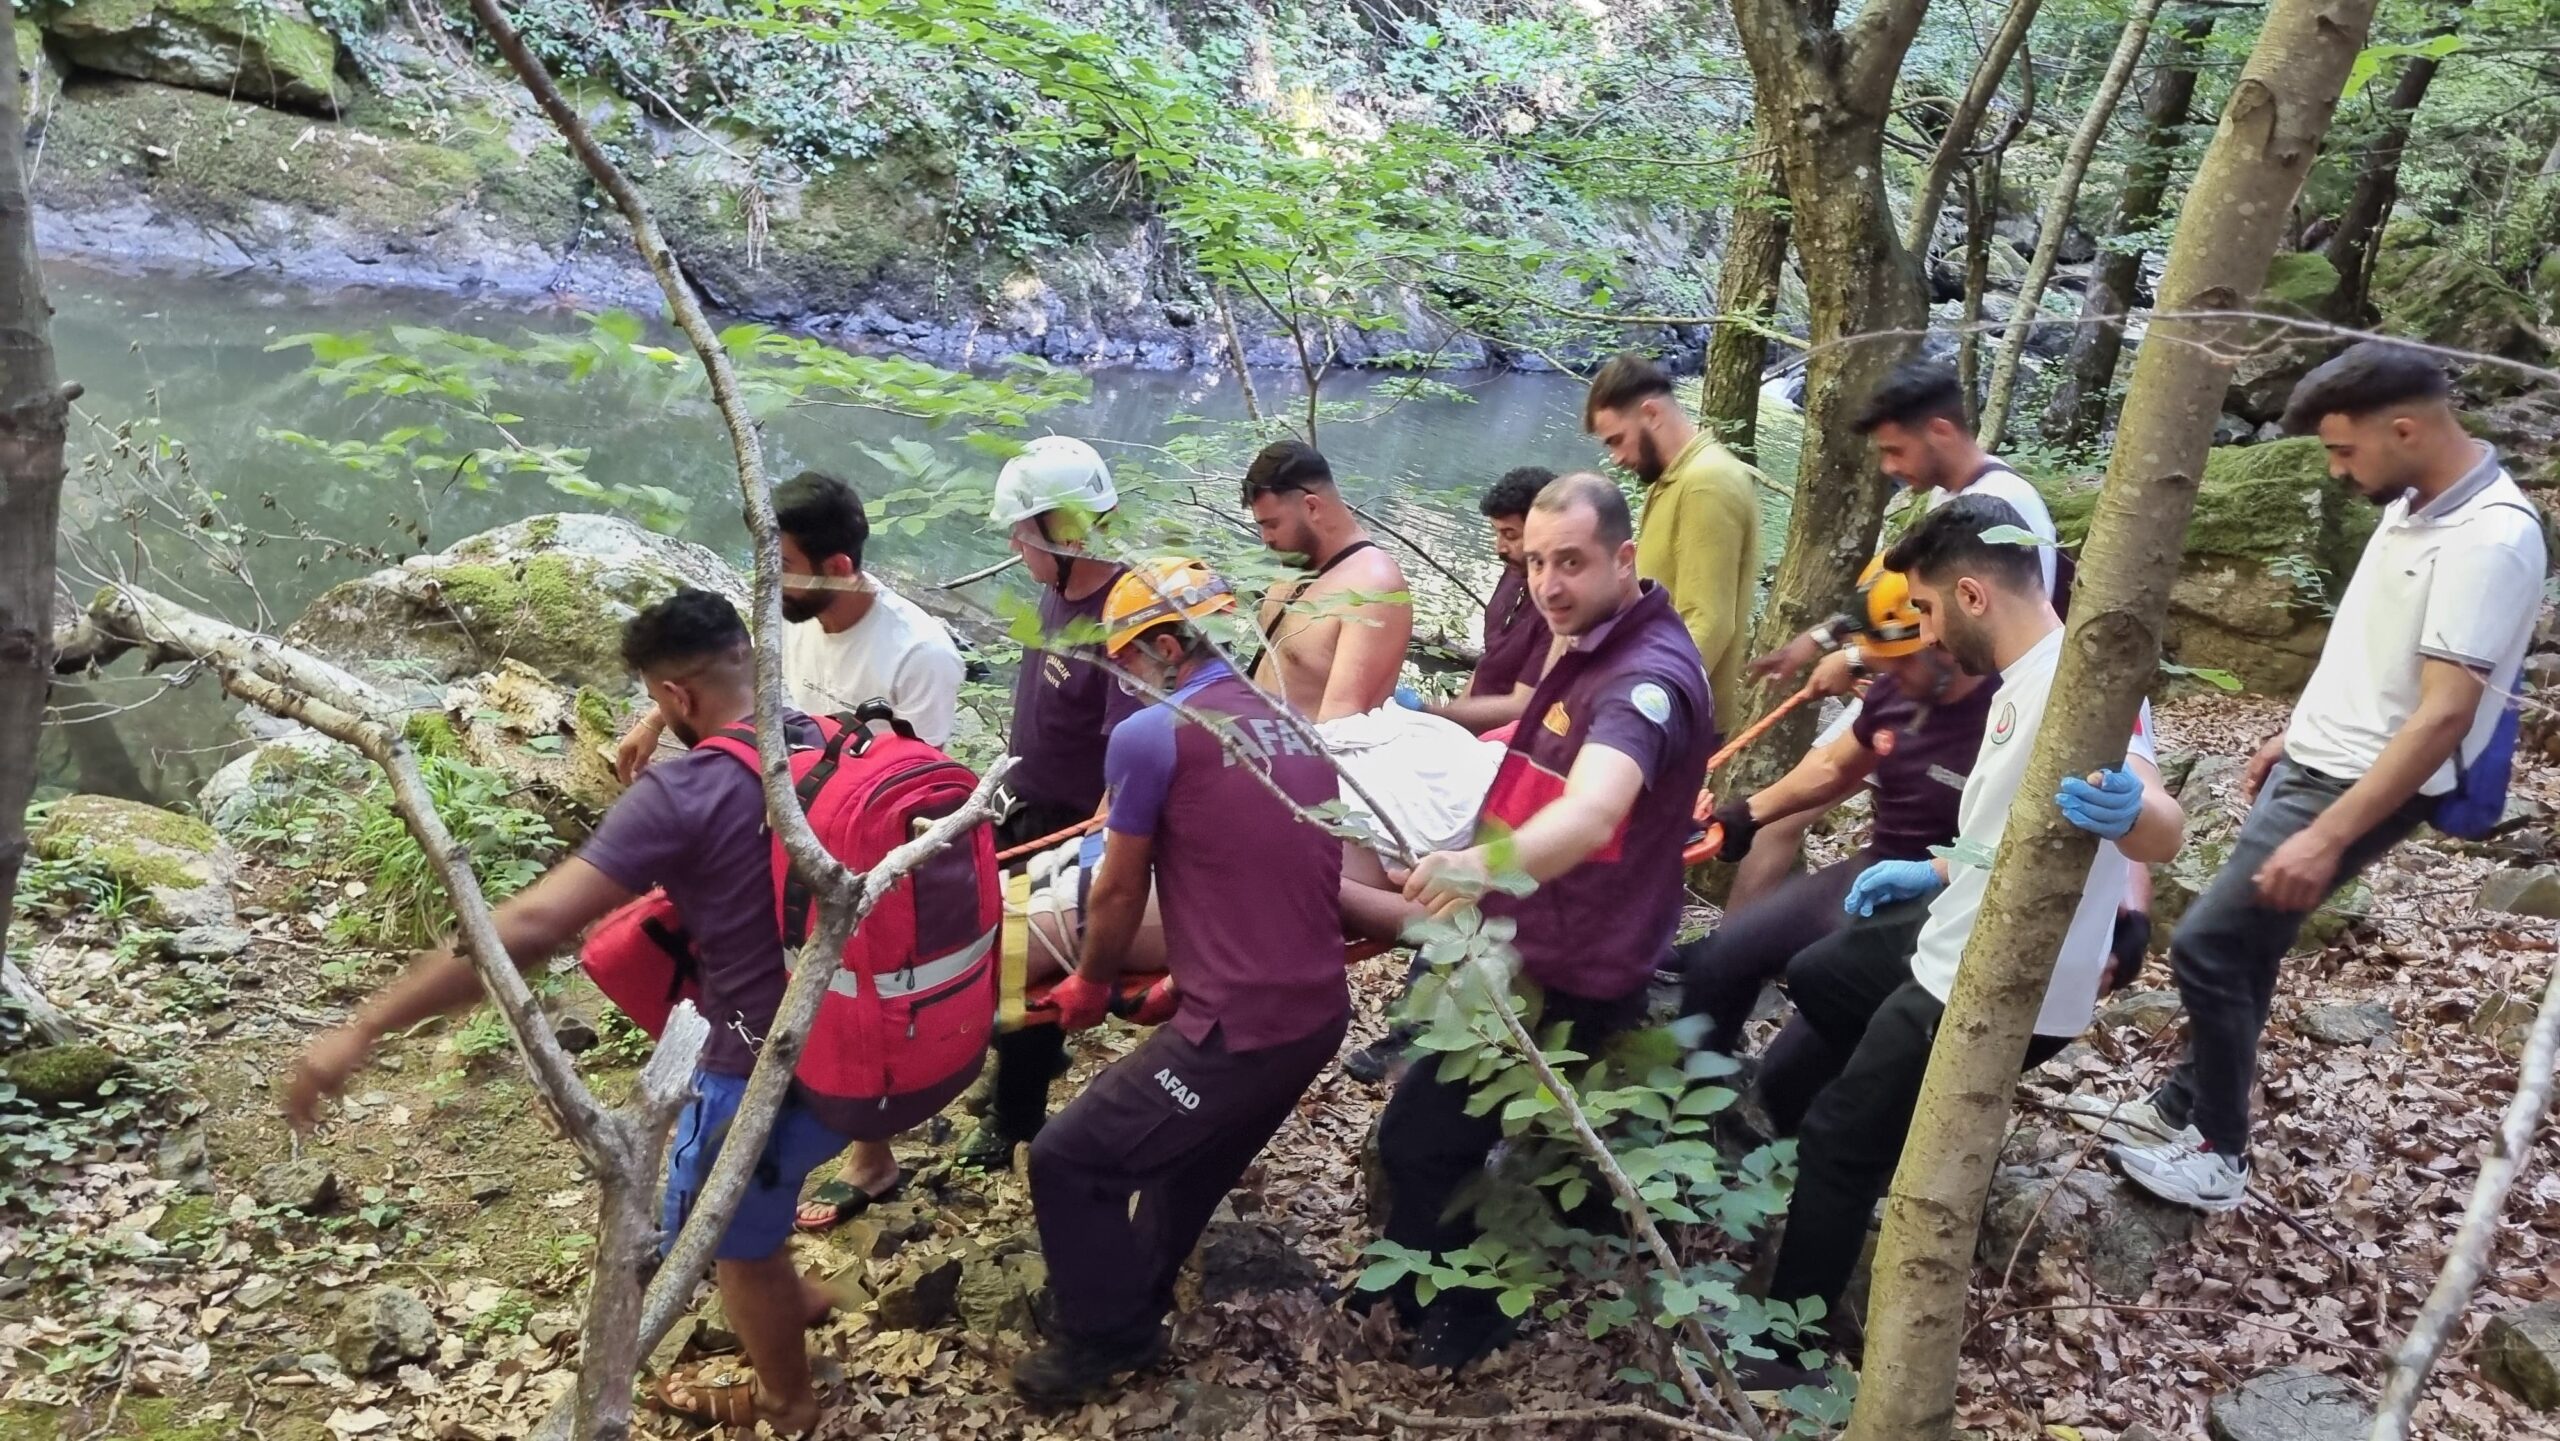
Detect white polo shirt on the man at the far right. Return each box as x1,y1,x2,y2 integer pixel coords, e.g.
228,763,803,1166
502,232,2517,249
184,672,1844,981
2284,445,2545,796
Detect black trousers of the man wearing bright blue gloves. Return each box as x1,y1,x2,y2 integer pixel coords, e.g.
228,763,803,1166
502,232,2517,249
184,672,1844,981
1769,901,2071,1313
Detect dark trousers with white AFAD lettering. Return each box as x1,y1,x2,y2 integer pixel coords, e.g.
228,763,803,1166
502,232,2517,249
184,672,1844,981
1032,1014,1352,1341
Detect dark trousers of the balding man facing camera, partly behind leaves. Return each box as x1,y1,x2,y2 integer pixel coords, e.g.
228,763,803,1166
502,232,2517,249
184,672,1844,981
1377,988,1644,1321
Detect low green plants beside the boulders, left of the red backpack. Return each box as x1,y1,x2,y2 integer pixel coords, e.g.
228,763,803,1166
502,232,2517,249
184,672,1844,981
241,752,561,952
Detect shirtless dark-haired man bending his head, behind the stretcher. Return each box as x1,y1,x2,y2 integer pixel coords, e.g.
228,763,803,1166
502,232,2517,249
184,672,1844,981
1244,440,1413,722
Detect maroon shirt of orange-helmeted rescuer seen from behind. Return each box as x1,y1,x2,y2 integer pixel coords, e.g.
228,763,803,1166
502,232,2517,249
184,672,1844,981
1106,660,1352,1052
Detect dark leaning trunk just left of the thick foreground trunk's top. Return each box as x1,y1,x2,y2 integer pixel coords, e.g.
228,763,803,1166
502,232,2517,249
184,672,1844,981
2045,13,2214,445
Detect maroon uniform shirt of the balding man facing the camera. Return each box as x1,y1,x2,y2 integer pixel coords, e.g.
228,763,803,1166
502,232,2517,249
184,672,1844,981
1477,581,1715,1001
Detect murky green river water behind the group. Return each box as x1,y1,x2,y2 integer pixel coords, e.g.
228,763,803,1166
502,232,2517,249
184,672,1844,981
41,255,1795,804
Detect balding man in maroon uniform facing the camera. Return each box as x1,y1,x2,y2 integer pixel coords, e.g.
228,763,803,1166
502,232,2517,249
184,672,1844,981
1380,474,1715,1369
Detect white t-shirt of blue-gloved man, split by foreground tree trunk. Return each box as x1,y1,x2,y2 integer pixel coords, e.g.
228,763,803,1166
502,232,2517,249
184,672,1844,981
1912,627,2156,1037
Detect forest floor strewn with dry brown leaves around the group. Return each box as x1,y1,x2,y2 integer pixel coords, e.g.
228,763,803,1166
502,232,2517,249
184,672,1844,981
0,699,2560,1441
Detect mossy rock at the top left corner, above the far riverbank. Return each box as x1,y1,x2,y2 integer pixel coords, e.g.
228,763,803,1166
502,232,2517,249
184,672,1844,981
46,0,338,110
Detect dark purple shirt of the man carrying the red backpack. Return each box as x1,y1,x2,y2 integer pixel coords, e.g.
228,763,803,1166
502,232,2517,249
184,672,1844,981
579,712,819,1075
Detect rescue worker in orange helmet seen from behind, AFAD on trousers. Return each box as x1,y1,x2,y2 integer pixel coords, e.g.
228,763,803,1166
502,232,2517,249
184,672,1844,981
1014,561,1352,1405
